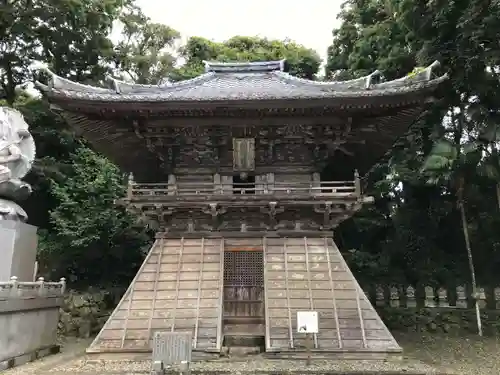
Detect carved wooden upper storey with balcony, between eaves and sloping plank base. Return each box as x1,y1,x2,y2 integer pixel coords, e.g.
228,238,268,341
122,119,372,233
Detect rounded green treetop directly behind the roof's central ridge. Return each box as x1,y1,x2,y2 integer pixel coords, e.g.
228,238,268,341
172,36,321,80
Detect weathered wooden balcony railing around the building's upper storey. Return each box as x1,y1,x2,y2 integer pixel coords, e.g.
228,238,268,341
127,180,361,200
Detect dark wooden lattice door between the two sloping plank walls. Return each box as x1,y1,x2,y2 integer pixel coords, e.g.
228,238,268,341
224,250,264,318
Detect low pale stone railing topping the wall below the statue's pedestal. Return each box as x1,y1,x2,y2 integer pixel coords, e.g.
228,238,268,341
0,276,66,300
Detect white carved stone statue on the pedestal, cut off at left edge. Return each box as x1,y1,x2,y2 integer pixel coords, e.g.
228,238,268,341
0,107,36,222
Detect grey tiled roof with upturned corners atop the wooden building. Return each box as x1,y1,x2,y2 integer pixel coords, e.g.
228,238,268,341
37,61,447,102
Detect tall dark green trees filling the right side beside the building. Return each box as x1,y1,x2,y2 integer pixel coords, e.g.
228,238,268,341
327,0,500,292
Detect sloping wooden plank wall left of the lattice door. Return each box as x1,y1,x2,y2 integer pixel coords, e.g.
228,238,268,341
87,238,223,353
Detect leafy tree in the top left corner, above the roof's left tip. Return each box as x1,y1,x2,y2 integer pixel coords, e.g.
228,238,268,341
0,0,129,105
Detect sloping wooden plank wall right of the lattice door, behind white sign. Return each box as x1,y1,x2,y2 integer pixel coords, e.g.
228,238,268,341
265,238,400,352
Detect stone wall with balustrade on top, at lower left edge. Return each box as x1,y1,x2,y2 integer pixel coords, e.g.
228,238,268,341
0,277,66,371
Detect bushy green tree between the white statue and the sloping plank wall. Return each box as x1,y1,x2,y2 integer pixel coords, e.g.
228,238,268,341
40,147,148,287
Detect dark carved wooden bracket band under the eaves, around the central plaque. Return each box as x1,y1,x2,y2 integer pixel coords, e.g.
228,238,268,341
133,122,364,171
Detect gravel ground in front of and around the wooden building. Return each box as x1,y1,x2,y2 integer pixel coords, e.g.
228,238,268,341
2,334,500,375
